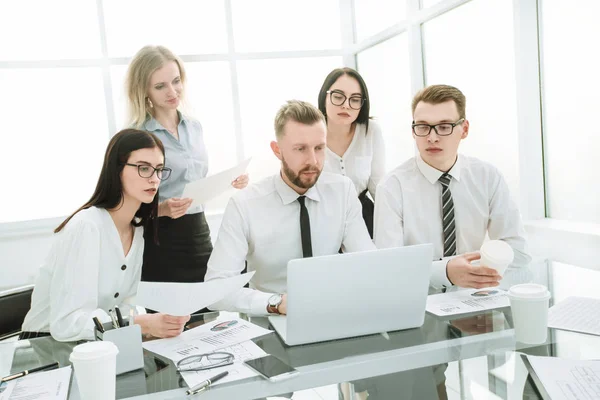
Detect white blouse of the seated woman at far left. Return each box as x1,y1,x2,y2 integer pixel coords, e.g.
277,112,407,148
22,207,144,341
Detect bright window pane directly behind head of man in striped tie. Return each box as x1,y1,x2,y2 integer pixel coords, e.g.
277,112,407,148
423,0,519,201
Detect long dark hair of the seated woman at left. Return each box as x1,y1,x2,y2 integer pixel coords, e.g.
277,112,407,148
54,129,165,238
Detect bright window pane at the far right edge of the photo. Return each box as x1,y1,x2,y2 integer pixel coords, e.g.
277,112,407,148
541,0,600,223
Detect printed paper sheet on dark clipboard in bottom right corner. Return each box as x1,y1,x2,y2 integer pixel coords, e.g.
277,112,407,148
527,356,600,400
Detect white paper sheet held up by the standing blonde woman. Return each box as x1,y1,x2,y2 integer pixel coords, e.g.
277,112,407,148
181,157,252,206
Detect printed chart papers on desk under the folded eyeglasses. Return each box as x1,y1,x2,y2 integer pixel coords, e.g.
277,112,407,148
143,318,273,387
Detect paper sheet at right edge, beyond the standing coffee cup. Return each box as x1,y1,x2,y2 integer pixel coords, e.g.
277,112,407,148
548,296,600,335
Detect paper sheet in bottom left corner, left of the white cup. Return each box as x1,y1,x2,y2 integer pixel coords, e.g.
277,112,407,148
0,366,71,400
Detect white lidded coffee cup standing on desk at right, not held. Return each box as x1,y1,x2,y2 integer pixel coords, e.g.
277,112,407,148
508,283,550,344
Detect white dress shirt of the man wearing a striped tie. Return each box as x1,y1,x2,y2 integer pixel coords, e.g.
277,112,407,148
374,155,531,287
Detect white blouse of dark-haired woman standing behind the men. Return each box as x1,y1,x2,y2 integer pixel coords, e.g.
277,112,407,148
323,120,385,198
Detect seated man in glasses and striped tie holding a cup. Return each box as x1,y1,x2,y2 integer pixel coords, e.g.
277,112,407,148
374,85,531,288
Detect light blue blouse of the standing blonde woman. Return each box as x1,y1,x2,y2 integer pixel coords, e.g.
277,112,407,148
144,111,208,214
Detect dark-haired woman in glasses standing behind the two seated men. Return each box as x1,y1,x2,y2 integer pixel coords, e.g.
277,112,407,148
318,68,385,238
